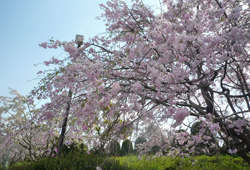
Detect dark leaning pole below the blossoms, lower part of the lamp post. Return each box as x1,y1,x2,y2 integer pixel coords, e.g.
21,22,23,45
57,90,72,157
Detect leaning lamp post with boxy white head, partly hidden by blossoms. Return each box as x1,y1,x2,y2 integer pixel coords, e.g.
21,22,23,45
57,34,83,157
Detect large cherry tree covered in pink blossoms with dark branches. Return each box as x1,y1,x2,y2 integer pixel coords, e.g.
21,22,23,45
33,0,250,164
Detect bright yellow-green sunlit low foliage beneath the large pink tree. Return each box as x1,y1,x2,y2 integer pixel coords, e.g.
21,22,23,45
117,155,250,170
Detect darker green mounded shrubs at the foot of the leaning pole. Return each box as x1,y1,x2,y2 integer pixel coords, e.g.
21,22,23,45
8,152,128,170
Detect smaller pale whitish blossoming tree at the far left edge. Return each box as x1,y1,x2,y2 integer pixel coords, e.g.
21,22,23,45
0,89,59,163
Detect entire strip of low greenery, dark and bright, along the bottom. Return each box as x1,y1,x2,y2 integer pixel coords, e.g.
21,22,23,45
8,152,250,170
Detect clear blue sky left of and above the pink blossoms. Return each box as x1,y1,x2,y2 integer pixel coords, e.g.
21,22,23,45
0,0,156,96
